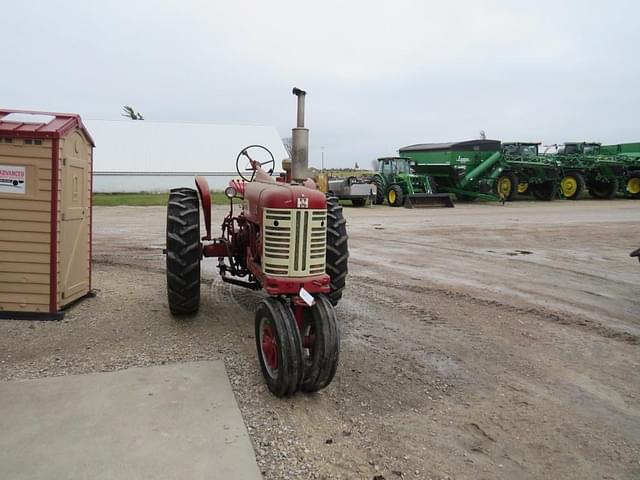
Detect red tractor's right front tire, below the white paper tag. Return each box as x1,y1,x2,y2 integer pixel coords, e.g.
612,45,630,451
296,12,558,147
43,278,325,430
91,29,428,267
300,294,340,392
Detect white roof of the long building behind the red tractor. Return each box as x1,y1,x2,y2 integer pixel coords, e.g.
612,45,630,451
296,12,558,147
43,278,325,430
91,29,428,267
84,120,288,173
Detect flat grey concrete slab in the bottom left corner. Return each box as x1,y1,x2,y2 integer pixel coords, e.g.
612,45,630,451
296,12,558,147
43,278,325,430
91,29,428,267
0,362,262,480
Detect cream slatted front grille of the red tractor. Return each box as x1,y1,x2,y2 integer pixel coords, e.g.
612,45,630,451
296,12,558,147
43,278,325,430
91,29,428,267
262,208,327,277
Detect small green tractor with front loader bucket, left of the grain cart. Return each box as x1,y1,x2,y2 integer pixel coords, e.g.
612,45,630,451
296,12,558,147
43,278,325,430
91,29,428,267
373,157,453,208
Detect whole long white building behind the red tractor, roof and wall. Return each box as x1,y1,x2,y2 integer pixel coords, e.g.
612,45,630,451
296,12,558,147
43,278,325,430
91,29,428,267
84,120,288,192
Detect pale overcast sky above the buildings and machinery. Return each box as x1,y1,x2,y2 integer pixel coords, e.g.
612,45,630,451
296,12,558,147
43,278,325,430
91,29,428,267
0,0,640,167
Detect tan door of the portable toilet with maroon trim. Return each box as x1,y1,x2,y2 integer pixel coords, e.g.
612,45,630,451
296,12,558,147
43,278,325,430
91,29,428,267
60,132,89,305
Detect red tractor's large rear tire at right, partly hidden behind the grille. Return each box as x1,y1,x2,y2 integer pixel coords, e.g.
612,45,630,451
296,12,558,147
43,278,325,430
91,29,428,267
326,197,349,306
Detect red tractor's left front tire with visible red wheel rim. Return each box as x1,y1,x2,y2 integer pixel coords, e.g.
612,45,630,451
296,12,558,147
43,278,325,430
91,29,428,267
255,297,304,397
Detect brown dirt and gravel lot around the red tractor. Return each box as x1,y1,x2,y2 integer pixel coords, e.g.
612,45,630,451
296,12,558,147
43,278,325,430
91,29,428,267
0,200,640,480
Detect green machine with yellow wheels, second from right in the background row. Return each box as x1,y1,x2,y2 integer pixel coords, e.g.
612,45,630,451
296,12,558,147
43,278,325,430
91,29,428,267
548,142,629,200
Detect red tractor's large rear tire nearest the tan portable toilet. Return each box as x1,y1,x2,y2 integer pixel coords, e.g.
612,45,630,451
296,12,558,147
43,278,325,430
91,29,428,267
166,188,202,315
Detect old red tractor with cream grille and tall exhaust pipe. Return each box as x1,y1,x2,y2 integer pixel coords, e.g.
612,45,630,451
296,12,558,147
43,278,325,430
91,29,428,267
166,88,349,397
